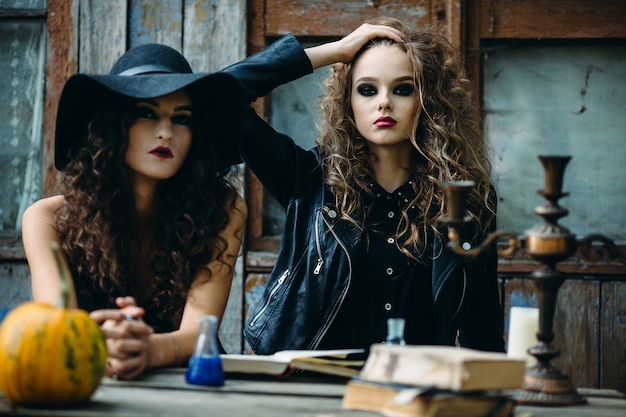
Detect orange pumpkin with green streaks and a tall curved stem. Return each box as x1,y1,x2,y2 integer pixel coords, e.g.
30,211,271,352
0,244,107,405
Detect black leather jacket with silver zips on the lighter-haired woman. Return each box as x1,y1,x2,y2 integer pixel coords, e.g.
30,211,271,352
224,35,504,354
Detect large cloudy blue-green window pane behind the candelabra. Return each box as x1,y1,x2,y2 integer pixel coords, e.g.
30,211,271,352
483,45,626,241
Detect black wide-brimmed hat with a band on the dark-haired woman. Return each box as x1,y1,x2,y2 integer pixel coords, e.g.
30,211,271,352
54,43,247,171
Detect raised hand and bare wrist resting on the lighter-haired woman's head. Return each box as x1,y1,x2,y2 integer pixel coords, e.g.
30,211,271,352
305,23,403,69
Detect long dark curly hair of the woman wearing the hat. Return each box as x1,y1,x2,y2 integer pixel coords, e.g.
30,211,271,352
56,91,236,331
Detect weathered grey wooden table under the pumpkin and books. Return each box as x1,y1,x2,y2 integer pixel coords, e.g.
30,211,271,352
0,369,626,417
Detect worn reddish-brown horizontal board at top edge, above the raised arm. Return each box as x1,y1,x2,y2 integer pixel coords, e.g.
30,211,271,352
265,0,432,36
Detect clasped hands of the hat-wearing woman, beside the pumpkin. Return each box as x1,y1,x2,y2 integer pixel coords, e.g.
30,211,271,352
90,297,153,380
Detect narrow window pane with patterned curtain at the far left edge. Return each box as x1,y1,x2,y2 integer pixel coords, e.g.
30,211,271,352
0,20,45,231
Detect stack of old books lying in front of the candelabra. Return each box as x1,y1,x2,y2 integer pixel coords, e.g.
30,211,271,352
342,344,526,417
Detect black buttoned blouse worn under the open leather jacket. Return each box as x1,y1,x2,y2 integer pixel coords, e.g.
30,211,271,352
320,180,436,349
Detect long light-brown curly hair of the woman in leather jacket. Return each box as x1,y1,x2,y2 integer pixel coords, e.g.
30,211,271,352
317,17,495,258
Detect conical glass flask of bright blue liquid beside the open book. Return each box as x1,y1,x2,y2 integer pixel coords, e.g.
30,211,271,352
185,316,224,386
